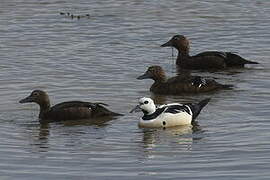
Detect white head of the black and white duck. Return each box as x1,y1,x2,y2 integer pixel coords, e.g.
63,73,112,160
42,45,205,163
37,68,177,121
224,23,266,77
130,97,156,115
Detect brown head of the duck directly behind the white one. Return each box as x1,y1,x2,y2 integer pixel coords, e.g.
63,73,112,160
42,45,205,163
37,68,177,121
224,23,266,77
137,66,166,81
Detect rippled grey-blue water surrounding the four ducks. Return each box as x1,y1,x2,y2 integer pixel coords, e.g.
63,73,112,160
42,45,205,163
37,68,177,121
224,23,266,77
0,0,270,180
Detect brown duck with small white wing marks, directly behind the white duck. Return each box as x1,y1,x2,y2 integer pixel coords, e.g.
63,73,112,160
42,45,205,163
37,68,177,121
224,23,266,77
137,66,233,95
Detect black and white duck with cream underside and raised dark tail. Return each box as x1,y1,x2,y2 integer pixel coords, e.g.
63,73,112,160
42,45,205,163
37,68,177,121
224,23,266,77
130,97,210,128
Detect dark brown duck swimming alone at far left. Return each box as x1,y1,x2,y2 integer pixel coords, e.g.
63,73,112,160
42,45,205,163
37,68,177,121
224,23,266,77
19,90,122,122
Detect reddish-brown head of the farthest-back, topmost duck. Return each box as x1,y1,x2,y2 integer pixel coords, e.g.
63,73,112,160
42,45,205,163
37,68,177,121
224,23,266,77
161,35,190,54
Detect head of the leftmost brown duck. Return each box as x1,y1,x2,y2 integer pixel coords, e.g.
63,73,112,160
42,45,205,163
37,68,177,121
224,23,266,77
19,90,50,108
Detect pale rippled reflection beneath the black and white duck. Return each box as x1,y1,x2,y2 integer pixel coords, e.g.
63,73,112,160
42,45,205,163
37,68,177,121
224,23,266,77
139,123,203,161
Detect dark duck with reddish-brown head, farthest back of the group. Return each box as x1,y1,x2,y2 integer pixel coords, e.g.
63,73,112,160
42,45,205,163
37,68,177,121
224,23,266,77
161,35,259,70
